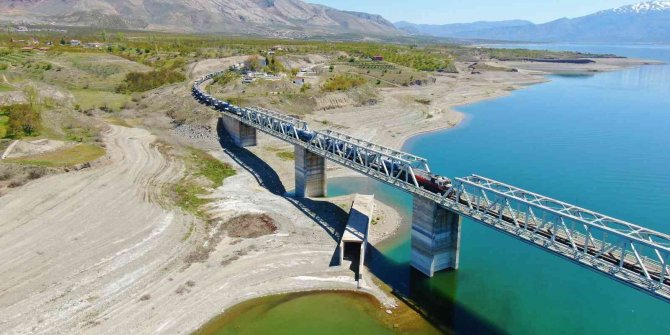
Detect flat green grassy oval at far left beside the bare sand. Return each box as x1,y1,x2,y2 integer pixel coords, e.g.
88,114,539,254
7,144,105,167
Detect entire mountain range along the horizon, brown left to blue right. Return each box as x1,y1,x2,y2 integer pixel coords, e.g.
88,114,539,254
0,0,670,43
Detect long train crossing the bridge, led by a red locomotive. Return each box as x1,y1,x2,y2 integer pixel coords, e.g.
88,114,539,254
191,72,454,195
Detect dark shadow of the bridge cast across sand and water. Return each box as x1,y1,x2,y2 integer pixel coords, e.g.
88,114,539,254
217,119,507,335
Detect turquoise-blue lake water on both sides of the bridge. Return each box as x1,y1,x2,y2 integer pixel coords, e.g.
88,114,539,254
329,45,670,334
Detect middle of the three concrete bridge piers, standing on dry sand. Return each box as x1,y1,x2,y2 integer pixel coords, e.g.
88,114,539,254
295,145,327,198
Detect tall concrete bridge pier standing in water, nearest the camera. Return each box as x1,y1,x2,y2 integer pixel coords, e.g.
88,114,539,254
411,196,461,277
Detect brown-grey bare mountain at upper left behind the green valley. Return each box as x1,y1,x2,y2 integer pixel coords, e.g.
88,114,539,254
0,0,403,36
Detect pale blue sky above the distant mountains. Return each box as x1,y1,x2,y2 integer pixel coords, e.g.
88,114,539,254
306,0,642,24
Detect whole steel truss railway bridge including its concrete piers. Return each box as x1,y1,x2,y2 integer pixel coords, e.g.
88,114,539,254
193,72,670,302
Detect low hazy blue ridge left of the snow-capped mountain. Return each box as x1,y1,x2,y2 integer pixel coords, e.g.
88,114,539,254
393,20,533,37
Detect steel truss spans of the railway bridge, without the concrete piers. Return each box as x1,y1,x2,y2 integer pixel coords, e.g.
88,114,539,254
193,72,670,302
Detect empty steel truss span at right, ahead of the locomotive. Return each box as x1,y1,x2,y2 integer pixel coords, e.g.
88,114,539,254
455,175,670,299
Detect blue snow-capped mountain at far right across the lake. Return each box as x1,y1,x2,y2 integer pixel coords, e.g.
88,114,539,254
399,1,670,43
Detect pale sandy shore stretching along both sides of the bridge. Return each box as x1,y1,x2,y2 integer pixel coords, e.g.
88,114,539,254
0,59,643,334
